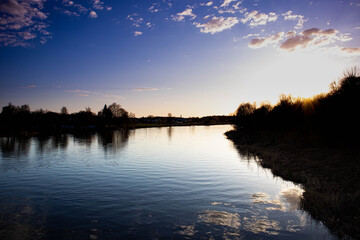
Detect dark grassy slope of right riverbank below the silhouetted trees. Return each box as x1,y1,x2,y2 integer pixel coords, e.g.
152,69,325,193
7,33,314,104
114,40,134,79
225,129,360,239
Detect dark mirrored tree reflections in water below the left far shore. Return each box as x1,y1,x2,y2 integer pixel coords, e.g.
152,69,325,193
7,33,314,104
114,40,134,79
0,130,133,159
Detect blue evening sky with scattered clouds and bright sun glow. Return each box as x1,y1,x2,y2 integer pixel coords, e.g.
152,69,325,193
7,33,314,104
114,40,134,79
0,0,360,117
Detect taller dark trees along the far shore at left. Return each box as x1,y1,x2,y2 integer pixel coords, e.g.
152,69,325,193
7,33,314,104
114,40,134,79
0,103,135,134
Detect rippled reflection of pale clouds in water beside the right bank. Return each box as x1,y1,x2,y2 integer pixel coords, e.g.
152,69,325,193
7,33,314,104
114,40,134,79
177,187,306,239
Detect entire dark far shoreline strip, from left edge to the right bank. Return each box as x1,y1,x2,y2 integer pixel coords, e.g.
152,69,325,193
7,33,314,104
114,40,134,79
0,103,233,136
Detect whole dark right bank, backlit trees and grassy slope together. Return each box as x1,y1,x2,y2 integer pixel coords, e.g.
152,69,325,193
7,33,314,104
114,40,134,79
226,67,360,239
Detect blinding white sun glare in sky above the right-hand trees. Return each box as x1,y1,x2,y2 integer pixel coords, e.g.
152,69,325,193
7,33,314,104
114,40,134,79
244,52,347,104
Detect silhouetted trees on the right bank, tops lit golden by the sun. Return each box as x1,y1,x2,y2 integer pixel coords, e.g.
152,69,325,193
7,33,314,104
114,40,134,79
235,67,360,145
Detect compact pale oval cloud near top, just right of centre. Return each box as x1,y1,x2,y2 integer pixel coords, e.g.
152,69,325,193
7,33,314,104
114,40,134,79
194,17,239,34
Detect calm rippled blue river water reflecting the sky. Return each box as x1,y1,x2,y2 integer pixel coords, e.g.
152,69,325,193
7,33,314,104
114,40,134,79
0,126,333,239
